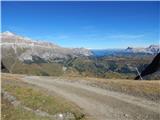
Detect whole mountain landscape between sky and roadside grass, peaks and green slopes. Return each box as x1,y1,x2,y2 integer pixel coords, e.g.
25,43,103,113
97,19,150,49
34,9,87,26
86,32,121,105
0,32,160,79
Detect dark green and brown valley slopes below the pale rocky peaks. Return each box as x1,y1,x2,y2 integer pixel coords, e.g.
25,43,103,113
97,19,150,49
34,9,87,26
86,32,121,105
2,50,158,79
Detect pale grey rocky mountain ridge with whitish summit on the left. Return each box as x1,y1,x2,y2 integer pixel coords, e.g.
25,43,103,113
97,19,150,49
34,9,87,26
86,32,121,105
1,31,92,61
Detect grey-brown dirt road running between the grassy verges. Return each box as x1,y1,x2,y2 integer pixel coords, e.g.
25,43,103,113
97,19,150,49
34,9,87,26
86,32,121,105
24,76,160,120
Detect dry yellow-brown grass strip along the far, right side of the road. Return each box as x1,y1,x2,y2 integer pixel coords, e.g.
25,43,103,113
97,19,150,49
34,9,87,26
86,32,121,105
60,77,160,102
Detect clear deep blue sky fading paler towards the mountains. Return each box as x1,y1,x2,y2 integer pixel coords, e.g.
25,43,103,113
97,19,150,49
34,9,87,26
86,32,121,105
1,1,160,49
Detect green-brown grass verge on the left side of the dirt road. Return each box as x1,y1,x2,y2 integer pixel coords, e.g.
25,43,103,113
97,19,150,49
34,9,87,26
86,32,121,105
2,74,85,120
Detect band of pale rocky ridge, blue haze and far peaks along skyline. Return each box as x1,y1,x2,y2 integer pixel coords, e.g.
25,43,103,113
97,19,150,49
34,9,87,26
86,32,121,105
0,31,160,61
